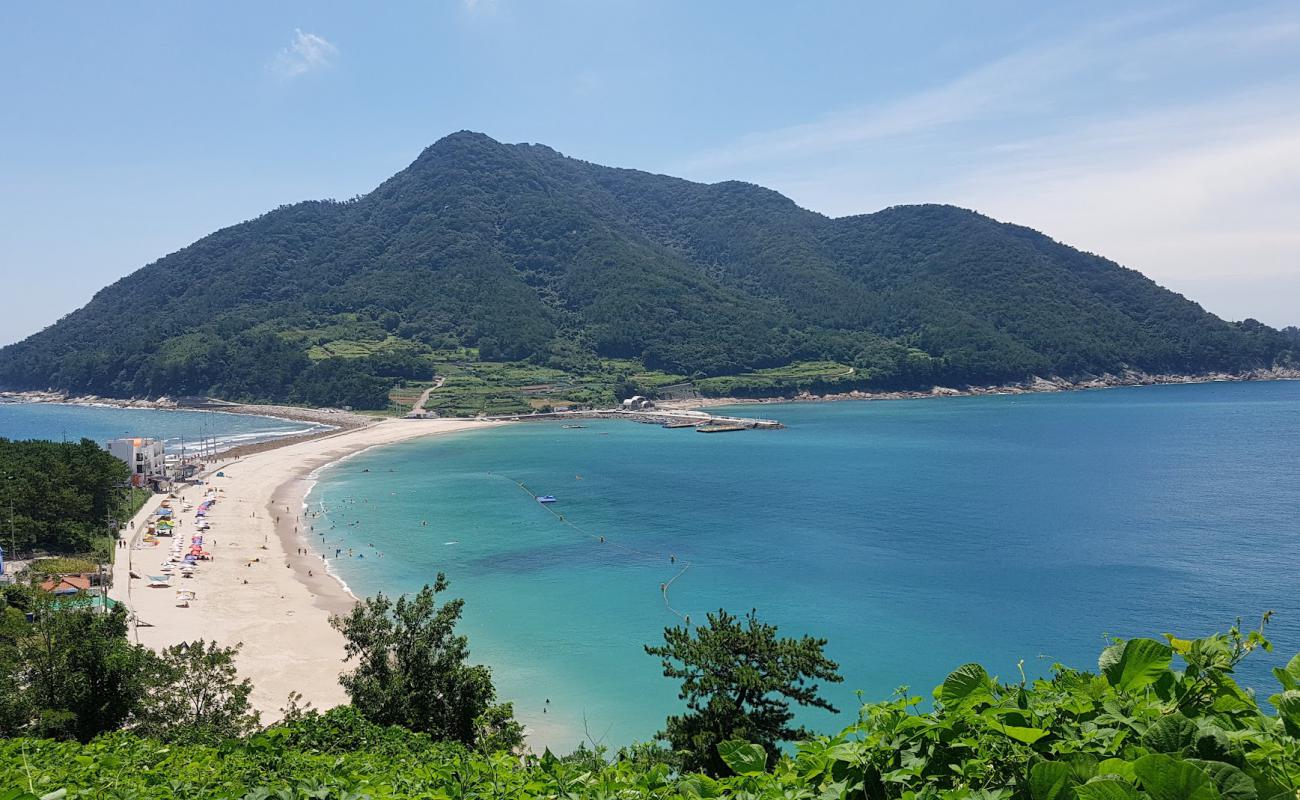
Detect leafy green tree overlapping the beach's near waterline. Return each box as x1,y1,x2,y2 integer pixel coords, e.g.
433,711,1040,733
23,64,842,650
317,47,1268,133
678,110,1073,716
332,572,523,751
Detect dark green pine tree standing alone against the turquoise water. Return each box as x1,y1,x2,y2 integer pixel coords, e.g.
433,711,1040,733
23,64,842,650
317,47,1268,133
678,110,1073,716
646,610,842,775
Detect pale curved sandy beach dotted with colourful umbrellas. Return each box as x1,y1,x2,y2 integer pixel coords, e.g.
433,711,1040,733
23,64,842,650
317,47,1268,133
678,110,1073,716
111,419,504,723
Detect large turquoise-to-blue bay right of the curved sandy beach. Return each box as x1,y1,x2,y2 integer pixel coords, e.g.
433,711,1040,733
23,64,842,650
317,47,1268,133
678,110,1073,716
309,382,1300,751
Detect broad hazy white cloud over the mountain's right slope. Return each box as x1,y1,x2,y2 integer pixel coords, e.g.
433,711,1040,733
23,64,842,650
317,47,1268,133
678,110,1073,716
679,9,1300,324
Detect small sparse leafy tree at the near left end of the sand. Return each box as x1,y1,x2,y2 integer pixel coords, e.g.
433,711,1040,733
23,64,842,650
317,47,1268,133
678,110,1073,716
137,639,260,741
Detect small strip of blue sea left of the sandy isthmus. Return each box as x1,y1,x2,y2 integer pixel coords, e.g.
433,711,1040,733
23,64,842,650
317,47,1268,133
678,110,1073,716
0,403,330,451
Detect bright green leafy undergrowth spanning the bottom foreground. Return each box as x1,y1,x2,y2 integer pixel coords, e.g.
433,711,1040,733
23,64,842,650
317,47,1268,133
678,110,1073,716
0,600,1300,800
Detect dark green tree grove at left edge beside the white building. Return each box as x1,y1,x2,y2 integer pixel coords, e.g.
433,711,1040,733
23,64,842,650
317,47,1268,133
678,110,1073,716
0,438,135,556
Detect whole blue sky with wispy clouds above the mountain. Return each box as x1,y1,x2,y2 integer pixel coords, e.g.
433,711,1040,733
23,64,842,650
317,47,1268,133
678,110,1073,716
0,0,1300,343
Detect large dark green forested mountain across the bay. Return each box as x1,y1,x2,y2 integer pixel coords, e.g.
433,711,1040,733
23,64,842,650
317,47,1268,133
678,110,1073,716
0,133,1297,406
